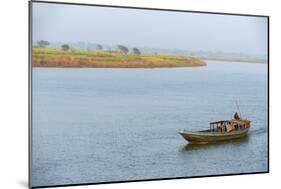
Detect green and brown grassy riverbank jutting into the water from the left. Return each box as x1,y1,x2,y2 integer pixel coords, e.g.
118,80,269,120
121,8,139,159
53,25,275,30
32,48,207,68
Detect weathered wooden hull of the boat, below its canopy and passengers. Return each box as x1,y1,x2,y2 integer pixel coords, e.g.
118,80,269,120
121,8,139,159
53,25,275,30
179,128,249,144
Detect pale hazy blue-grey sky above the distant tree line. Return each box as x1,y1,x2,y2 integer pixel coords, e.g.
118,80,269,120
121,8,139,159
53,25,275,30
33,2,267,55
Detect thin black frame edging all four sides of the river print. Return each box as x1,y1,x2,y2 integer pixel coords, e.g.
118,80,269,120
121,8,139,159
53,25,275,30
28,0,270,188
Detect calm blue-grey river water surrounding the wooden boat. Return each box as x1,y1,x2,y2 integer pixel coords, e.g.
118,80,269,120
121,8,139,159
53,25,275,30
32,61,268,186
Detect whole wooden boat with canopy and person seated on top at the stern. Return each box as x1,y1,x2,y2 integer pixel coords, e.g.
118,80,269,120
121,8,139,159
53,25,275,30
179,113,251,144
